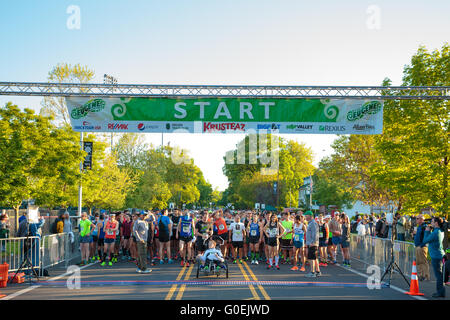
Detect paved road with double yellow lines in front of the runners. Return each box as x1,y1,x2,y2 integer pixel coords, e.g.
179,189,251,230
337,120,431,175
0,256,436,300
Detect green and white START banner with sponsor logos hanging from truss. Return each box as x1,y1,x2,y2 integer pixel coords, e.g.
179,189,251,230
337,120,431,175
66,98,383,134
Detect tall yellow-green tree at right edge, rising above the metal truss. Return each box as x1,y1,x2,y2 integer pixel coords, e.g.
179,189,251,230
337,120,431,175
373,43,450,216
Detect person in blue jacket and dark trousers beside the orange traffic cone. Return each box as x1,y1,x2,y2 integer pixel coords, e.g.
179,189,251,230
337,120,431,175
423,217,445,298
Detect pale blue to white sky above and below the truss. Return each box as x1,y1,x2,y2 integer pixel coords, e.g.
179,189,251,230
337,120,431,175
0,0,450,190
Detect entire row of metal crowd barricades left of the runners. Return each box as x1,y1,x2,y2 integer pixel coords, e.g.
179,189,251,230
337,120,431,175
0,232,81,272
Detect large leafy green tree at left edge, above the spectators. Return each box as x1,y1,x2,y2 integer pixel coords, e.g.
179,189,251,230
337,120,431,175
0,103,84,227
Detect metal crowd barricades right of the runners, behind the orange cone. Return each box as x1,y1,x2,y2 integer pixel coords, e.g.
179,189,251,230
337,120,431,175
350,234,415,277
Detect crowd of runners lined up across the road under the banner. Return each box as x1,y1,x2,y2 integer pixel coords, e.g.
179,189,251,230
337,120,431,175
80,210,351,277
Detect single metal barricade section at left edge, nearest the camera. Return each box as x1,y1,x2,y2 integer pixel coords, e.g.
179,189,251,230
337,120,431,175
0,237,41,271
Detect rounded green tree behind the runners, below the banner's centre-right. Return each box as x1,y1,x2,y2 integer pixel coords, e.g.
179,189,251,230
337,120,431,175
223,134,314,208
